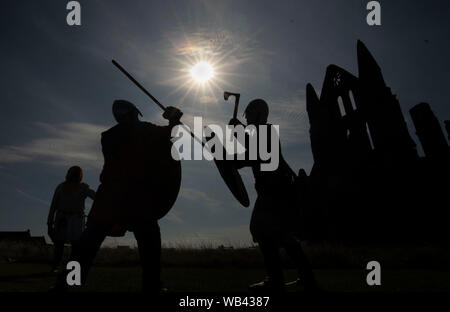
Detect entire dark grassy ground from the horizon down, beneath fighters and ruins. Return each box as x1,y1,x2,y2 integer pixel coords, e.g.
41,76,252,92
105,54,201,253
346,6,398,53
0,244,450,292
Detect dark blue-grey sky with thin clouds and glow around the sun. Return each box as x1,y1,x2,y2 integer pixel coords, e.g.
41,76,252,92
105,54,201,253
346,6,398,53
0,0,450,246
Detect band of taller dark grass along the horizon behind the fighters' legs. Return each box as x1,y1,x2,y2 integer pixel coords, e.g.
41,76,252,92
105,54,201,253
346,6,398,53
0,243,450,269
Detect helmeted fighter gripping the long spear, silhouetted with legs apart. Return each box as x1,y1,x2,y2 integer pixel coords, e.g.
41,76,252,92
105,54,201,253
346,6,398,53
54,100,182,292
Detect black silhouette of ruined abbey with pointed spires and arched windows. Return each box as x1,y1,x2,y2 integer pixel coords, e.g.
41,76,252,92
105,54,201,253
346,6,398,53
300,41,450,242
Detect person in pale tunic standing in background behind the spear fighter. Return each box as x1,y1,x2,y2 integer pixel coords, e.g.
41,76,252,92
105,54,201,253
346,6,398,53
47,166,95,272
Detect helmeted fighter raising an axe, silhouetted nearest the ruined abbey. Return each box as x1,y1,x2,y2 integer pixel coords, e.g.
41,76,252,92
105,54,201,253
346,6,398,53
230,99,317,292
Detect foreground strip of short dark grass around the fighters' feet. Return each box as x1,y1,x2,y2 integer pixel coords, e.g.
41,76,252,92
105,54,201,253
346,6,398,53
0,263,450,292
